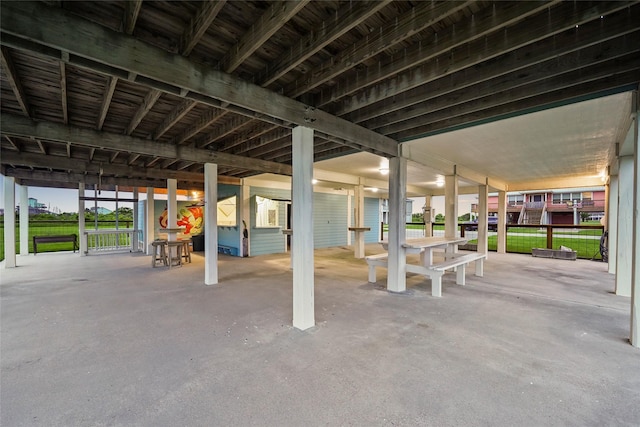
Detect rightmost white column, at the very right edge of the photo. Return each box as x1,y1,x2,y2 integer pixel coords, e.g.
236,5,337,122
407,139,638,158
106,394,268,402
629,98,640,347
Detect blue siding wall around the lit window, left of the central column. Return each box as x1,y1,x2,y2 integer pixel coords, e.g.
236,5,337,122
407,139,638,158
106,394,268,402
249,187,291,256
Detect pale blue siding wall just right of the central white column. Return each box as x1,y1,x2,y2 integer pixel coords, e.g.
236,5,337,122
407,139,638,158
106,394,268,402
313,193,347,248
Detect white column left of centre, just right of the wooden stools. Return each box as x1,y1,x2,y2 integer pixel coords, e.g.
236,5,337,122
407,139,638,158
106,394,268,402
206,163,218,285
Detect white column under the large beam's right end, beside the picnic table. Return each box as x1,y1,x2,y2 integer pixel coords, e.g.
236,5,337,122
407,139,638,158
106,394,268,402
387,157,407,292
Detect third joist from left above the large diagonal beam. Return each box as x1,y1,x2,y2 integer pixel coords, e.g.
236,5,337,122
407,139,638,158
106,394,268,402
220,0,310,73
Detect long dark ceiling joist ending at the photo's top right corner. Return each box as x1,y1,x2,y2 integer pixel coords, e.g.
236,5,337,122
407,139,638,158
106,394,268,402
333,2,630,116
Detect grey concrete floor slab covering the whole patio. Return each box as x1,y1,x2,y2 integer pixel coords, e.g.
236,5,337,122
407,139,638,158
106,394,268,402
0,249,640,426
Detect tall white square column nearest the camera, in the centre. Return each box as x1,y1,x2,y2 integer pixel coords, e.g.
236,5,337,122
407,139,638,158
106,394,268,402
291,126,315,330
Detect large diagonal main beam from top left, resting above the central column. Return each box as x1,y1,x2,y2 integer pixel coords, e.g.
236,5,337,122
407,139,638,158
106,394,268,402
0,2,398,156
